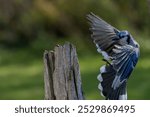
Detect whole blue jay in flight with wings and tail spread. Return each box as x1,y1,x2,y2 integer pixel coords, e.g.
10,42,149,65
87,13,139,100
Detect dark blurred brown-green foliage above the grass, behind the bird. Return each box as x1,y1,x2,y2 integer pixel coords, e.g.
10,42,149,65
0,0,150,46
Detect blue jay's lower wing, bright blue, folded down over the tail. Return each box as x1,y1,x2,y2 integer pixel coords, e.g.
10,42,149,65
112,45,139,89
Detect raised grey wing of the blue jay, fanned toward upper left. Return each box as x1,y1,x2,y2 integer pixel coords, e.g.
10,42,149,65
87,13,120,57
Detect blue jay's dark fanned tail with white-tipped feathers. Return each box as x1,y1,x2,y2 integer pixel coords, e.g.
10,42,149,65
97,65,127,100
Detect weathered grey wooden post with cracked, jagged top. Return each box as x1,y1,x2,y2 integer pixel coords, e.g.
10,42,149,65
44,43,84,100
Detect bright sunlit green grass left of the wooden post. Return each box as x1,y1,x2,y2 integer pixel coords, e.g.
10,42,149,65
0,61,44,99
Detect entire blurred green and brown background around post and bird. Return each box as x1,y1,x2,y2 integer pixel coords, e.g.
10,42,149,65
0,0,150,99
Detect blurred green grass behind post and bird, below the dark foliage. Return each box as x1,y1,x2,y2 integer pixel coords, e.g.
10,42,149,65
0,36,150,100
